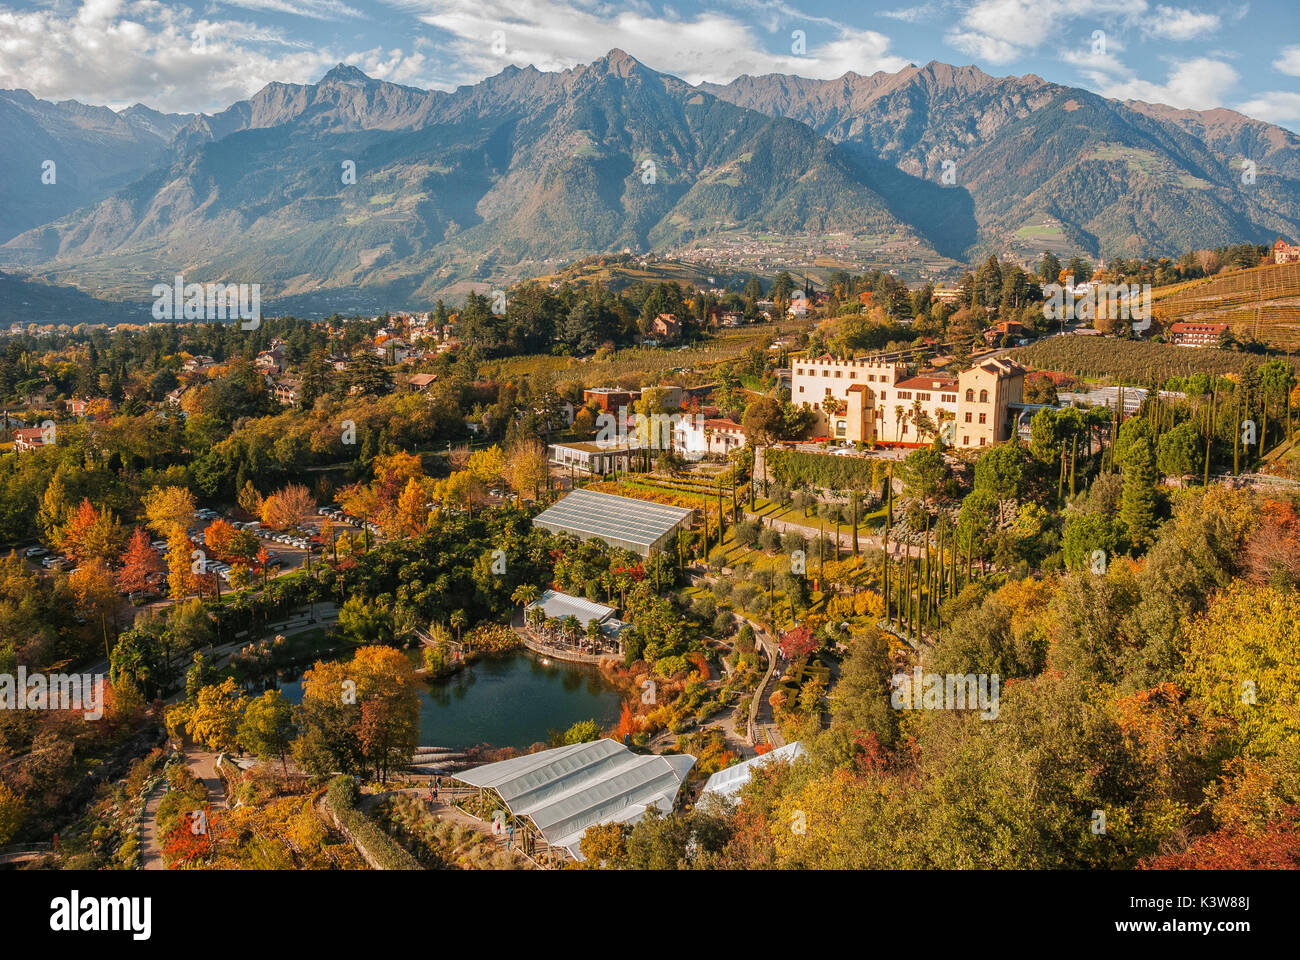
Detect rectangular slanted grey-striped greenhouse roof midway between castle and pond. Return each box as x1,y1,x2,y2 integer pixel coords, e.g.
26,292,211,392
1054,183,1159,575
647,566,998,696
533,489,694,557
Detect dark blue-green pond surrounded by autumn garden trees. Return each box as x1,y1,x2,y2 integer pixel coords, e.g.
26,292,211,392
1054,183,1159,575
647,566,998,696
271,652,621,749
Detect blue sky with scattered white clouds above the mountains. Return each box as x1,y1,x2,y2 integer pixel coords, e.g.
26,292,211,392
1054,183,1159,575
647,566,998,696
0,0,1300,133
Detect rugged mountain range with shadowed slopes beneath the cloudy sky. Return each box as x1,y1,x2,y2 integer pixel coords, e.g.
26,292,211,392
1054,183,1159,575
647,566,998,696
0,51,1300,306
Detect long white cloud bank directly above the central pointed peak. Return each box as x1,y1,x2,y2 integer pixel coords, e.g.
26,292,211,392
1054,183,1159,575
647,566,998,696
394,0,907,83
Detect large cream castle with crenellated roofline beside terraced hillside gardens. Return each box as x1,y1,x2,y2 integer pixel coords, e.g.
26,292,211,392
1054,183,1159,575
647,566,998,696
790,356,1024,447
